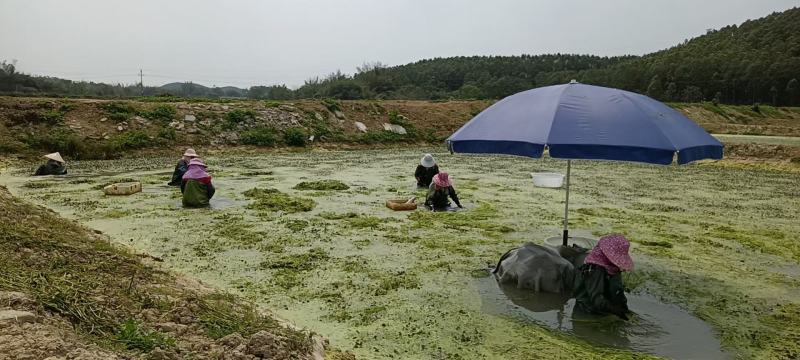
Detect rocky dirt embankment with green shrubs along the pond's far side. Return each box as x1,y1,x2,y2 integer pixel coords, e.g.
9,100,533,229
0,97,800,161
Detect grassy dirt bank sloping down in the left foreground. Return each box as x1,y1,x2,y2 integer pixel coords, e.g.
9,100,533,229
0,187,340,360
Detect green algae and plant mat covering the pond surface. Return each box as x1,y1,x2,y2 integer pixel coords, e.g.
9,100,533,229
0,149,800,359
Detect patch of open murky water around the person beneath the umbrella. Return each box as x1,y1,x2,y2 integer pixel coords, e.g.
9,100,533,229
477,276,727,359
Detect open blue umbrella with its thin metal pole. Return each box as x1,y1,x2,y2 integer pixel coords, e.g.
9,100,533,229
447,80,722,245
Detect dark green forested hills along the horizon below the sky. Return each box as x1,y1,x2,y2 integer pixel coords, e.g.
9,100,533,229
0,8,800,106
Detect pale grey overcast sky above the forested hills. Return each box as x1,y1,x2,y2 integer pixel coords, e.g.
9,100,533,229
0,0,800,87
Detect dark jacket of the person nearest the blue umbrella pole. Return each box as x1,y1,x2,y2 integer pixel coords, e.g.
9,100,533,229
572,264,628,320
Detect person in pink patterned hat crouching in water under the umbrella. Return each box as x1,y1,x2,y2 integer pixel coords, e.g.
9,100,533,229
573,235,633,320
